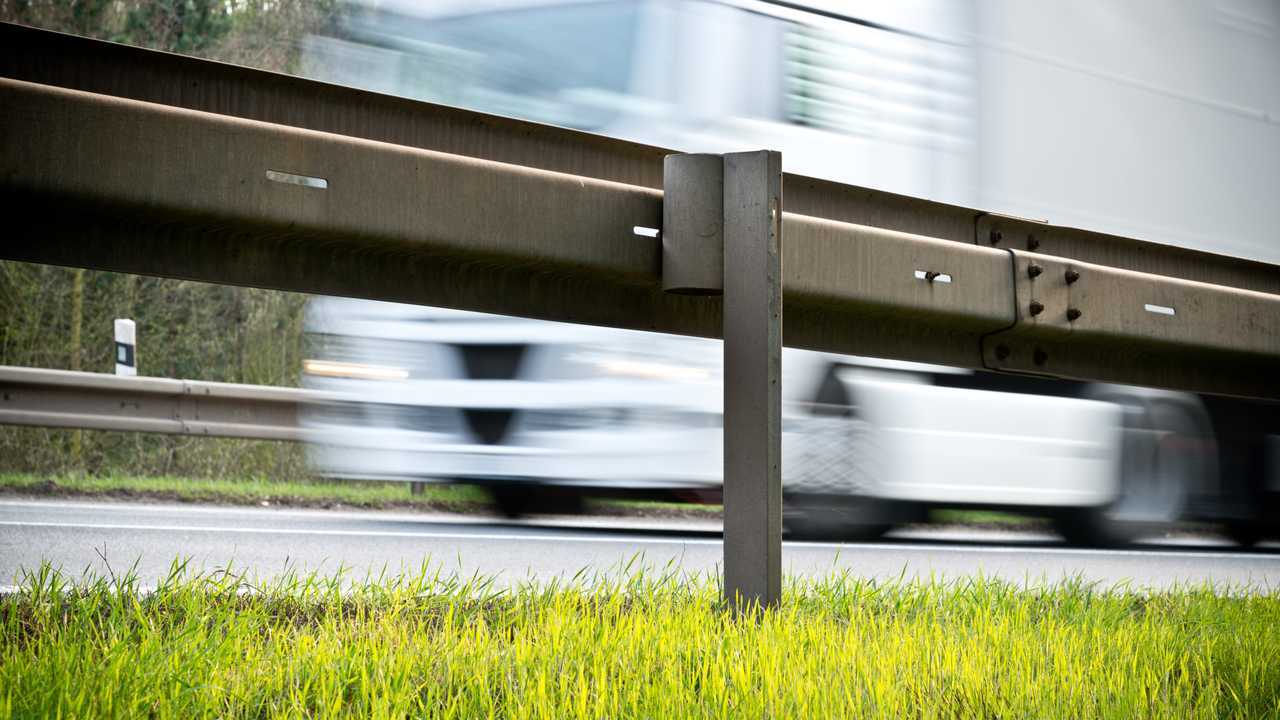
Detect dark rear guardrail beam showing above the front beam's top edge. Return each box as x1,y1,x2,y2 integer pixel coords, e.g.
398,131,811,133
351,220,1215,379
0,23,1280,293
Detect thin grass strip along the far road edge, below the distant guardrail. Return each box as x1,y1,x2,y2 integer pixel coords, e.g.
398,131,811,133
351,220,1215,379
0,473,488,511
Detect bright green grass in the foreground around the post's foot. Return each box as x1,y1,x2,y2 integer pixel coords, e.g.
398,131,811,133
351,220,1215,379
0,564,1280,719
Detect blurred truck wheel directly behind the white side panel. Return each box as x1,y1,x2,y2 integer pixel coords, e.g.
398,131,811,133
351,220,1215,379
1055,388,1210,547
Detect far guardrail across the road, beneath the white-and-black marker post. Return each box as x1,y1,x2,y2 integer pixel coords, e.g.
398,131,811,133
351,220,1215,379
0,368,307,441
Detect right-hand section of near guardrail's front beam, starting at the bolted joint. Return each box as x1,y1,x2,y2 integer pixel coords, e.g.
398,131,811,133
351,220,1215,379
982,244,1280,396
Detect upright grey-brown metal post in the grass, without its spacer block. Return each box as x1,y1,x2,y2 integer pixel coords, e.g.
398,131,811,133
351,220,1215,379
724,150,782,607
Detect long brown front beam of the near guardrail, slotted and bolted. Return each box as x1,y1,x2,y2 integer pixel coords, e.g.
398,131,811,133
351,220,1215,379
0,79,1280,397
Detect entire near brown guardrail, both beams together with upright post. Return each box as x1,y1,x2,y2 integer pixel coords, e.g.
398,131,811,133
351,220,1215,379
0,24,1280,603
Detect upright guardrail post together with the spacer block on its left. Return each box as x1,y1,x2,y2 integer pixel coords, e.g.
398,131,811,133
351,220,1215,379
662,150,782,609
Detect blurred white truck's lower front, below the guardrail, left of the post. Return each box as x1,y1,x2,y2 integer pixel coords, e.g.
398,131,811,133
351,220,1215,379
296,299,721,515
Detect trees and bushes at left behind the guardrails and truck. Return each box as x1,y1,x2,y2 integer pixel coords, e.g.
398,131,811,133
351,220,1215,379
0,0,342,478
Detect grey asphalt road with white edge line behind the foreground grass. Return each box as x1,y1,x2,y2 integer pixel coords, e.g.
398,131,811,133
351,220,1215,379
0,500,1280,589
